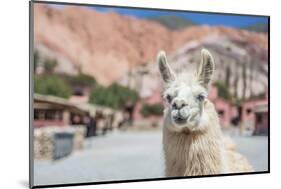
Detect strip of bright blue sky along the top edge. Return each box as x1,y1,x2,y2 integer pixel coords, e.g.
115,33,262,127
92,7,268,28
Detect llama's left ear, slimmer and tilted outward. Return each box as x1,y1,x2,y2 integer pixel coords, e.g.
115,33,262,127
157,51,176,84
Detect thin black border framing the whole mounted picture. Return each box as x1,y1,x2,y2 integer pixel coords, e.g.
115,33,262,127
29,0,271,188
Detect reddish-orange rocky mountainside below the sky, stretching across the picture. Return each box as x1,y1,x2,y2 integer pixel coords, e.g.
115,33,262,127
34,4,268,85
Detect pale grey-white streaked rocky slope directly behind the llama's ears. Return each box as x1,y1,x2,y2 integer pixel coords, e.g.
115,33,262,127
119,35,268,99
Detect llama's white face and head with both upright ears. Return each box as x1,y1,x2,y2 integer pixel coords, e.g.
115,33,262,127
157,49,215,131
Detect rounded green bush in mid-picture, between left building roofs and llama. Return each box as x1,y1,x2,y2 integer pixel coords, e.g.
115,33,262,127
90,83,139,109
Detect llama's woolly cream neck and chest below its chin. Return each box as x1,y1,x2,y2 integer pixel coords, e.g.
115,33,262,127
163,101,224,176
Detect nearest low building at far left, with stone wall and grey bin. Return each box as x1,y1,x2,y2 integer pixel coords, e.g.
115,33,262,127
33,94,88,160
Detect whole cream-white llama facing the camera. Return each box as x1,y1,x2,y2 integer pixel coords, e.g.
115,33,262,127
157,49,252,177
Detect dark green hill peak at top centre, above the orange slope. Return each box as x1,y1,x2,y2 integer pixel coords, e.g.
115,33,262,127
148,15,196,30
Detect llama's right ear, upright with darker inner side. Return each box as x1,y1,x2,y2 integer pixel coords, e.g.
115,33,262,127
197,49,215,89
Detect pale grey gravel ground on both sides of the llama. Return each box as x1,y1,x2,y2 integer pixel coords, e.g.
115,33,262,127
34,131,268,185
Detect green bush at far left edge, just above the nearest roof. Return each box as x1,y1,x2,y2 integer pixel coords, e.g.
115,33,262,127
34,75,72,98
